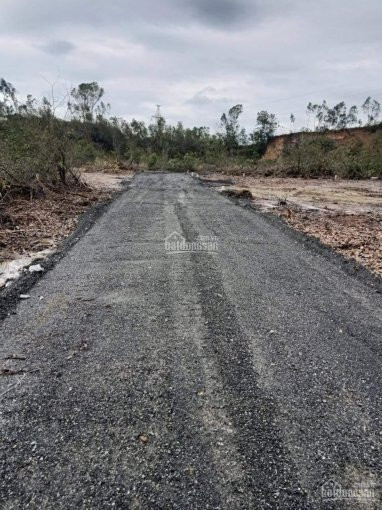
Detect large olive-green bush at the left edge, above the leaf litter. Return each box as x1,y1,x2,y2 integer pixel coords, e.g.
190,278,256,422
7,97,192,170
0,114,126,192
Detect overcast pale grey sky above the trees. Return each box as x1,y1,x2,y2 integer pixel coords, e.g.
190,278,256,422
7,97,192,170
0,0,382,131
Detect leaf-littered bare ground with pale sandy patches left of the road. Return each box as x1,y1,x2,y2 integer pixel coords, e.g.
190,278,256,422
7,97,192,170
0,171,131,287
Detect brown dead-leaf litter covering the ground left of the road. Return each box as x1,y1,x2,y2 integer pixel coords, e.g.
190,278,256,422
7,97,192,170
0,187,110,262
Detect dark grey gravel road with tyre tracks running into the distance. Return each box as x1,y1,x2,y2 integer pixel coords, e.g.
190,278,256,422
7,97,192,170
0,174,382,509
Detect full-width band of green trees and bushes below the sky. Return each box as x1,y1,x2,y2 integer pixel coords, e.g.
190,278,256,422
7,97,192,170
0,79,382,196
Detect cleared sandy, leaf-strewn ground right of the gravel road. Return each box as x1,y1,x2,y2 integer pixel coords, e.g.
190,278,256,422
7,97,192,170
203,174,382,275
